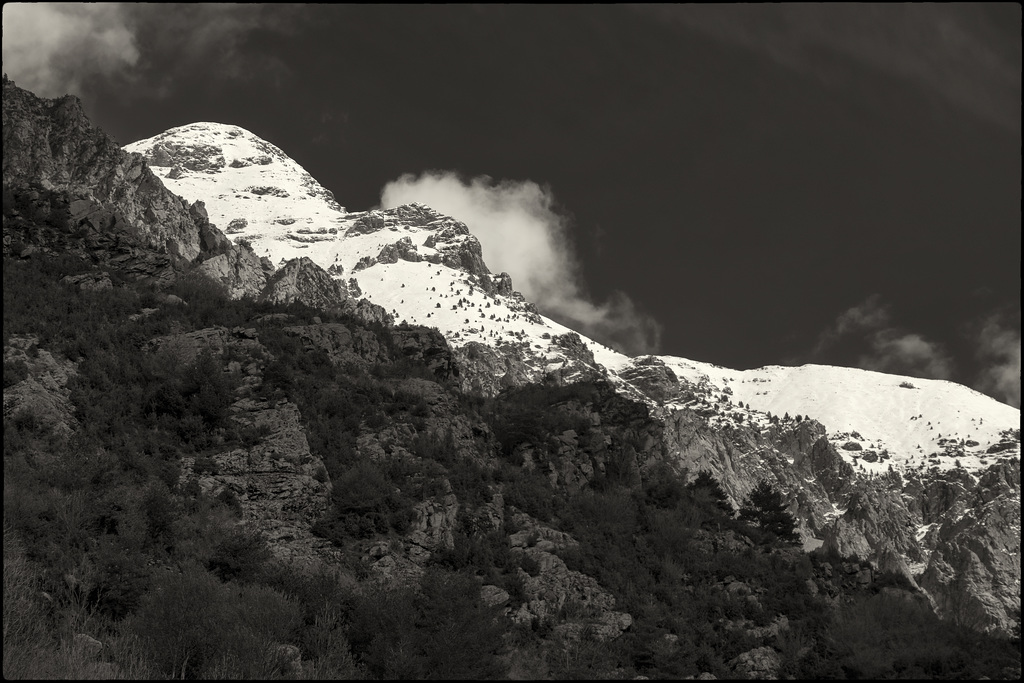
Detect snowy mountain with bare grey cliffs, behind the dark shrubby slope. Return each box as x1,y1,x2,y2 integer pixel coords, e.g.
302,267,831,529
126,118,1020,634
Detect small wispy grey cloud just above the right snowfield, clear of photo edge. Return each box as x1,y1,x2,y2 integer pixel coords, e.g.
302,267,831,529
811,294,954,379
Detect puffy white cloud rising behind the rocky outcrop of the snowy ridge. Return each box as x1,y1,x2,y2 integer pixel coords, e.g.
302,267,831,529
381,172,662,354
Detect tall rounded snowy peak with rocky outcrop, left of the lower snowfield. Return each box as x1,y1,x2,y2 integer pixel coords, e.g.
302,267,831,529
126,123,625,379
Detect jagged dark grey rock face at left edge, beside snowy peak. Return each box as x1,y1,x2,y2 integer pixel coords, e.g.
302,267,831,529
3,78,267,297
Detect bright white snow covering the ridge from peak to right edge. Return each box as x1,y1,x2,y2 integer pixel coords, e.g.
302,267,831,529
126,123,1020,473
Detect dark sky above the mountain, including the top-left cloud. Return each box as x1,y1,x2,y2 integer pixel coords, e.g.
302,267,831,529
3,4,1021,405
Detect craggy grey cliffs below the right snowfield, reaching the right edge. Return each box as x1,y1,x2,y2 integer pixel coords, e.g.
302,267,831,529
660,401,1020,630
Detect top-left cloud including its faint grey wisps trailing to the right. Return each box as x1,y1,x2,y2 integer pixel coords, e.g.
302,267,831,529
3,3,296,98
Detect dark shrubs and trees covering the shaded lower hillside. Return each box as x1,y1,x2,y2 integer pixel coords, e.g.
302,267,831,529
3,255,1020,679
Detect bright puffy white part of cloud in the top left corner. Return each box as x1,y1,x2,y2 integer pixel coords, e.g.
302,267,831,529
3,3,139,97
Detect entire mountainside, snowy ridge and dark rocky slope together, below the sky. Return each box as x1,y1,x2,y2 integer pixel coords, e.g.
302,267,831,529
3,79,1020,678
